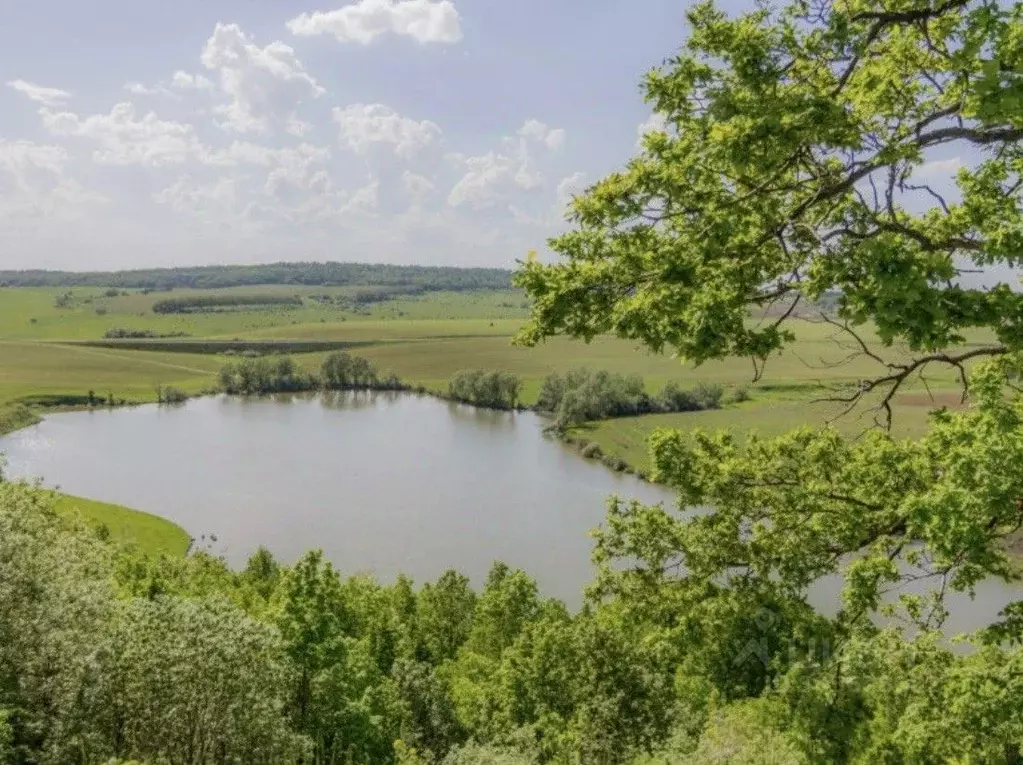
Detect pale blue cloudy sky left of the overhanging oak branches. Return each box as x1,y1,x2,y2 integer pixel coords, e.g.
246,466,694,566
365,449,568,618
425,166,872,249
0,0,712,270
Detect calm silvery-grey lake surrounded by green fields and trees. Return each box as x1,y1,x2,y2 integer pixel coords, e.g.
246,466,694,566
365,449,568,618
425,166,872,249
0,392,1023,633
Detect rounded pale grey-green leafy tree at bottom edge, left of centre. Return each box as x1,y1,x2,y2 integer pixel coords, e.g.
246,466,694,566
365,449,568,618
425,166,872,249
86,596,302,763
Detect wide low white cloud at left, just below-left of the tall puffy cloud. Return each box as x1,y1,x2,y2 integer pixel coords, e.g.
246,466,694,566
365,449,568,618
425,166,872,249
41,102,207,167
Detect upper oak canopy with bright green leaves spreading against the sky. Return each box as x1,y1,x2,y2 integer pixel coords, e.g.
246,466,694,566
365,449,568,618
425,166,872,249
517,0,1023,382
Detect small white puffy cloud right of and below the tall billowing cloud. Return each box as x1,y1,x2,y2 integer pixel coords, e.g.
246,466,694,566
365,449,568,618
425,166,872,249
332,103,441,159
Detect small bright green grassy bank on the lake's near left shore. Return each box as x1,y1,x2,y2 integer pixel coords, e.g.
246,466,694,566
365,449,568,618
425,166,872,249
55,494,190,556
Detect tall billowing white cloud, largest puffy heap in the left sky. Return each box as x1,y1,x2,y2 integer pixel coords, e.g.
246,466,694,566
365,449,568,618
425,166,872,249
201,23,325,133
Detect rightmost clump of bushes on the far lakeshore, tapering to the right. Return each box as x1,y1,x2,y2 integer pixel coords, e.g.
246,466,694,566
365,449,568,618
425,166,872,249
536,368,728,429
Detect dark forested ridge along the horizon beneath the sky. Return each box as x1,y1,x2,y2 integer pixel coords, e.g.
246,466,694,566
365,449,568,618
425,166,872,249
0,263,512,290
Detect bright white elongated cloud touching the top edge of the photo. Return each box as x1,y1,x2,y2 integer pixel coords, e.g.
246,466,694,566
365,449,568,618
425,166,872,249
287,0,461,45
